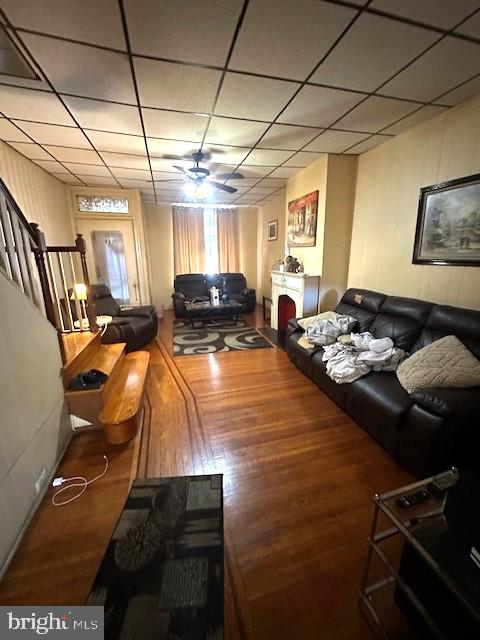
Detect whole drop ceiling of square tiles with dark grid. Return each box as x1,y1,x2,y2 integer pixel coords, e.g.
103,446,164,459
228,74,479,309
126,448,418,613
0,0,480,205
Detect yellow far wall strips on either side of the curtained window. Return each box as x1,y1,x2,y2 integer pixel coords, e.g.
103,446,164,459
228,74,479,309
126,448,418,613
143,203,257,309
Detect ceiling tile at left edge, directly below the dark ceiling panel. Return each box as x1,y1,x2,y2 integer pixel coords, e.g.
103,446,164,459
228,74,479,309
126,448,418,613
0,86,75,126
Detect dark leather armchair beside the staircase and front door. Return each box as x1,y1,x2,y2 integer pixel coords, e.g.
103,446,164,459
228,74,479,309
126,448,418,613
91,284,158,352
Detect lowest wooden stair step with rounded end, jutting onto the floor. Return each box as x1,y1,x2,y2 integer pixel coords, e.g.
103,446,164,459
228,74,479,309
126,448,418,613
99,351,150,444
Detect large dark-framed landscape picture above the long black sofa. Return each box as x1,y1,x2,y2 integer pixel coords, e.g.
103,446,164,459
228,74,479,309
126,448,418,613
413,174,480,266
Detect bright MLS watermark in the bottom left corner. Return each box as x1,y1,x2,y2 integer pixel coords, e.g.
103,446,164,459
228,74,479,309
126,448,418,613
0,607,104,640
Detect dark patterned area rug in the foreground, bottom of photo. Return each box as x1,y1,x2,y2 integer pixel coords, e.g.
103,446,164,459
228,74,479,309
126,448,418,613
87,475,224,640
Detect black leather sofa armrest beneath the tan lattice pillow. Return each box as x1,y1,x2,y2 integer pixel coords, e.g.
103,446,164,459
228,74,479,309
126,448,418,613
410,387,480,422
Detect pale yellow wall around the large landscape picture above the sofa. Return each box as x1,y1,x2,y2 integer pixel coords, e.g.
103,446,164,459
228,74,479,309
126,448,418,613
348,96,480,309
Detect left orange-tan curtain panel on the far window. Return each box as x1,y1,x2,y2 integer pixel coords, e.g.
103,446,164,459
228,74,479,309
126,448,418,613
172,207,205,275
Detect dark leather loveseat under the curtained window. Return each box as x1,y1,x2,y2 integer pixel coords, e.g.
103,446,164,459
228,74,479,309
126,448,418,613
172,273,256,318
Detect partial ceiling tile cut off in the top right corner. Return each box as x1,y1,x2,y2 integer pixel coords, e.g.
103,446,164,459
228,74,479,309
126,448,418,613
370,0,478,29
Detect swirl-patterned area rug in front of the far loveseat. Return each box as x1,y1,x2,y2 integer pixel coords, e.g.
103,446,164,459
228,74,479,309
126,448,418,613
173,320,272,356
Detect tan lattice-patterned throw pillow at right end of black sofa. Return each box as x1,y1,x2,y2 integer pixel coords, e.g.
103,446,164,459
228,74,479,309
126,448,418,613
397,336,480,393
